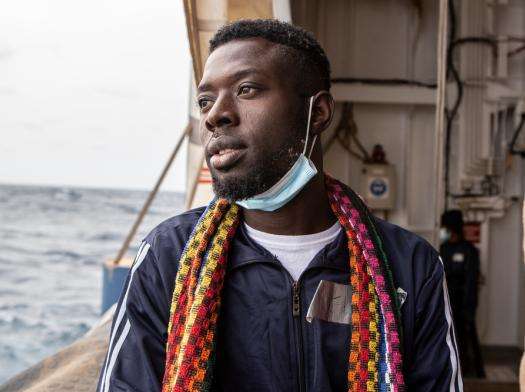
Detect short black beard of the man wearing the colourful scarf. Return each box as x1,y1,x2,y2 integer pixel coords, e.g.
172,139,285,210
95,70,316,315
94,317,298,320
208,107,306,202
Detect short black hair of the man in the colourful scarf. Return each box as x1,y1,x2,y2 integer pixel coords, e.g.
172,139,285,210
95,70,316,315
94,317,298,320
209,19,330,95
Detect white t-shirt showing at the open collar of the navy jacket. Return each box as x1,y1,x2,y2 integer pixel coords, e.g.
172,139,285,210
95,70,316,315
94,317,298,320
244,222,341,281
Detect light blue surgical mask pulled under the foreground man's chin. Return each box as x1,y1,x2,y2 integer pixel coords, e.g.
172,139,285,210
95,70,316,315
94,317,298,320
236,97,317,211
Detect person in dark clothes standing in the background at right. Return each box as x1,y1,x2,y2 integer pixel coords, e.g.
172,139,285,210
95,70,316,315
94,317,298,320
439,210,485,378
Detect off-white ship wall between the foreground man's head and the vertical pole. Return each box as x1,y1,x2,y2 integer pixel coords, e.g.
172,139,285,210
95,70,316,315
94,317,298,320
292,0,438,240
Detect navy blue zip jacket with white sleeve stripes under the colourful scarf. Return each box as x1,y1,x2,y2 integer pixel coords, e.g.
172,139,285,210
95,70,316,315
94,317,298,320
98,208,462,392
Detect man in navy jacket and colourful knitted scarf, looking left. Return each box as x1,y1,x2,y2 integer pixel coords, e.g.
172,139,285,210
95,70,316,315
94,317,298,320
99,20,462,391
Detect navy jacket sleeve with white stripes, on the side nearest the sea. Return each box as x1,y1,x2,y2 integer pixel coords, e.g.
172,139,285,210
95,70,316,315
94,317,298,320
97,242,169,392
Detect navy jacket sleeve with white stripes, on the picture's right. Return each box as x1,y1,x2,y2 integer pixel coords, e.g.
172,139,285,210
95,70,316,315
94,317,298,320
407,252,463,392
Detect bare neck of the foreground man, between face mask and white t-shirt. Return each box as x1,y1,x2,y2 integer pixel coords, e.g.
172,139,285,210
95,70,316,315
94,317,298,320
243,171,336,235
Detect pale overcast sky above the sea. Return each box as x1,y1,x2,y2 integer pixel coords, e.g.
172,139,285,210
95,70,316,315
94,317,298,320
0,0,191,191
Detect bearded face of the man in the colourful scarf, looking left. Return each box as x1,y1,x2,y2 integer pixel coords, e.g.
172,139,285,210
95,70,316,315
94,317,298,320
197,38,306,200
